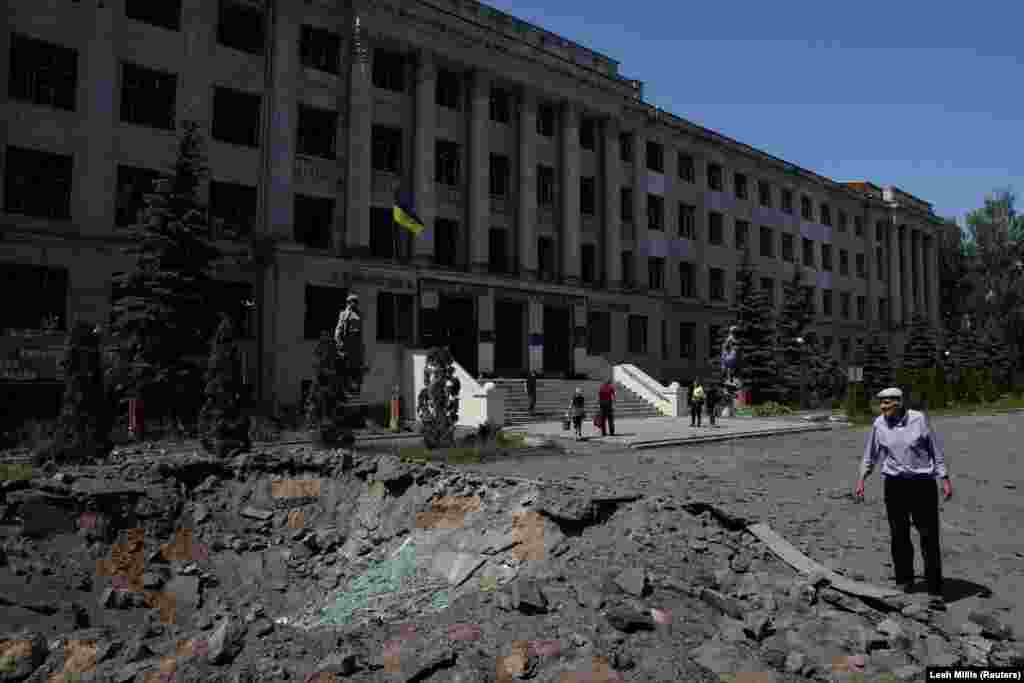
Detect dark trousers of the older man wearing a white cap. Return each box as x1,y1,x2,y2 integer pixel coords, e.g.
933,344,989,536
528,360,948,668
883,477,942,595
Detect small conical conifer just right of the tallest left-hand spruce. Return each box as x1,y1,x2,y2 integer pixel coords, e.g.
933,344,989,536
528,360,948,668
200,315,252,458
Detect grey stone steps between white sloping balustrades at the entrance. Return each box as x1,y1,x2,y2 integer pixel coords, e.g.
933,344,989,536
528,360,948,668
489,379,662,426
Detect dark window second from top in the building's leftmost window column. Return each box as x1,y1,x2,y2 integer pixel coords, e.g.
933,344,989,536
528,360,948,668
4,146,73,219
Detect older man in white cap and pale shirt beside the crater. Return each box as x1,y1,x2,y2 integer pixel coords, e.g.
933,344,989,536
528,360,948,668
853,387,953,609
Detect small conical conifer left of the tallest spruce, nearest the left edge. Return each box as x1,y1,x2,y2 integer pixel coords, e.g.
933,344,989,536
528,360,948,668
54,323,111,462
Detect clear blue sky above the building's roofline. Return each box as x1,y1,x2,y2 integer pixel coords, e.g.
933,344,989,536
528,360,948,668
486,0,1024,227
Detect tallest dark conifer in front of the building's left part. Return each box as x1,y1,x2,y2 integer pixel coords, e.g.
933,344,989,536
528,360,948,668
111,122,220,421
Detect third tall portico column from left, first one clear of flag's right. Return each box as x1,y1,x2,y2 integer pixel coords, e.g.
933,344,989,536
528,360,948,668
466,71,490,272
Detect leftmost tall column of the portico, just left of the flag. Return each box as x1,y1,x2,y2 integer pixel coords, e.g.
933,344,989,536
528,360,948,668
345,0,374,256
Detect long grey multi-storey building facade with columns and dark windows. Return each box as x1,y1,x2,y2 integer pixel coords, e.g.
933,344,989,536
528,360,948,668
0,0,940,417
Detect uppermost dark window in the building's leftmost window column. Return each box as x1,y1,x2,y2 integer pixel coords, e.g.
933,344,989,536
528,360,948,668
7,33,78,112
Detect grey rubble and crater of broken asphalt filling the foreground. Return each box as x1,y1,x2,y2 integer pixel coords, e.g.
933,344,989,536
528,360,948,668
0,446,1024,683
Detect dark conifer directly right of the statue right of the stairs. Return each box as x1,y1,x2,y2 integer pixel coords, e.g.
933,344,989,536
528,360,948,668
735,249,781,403
